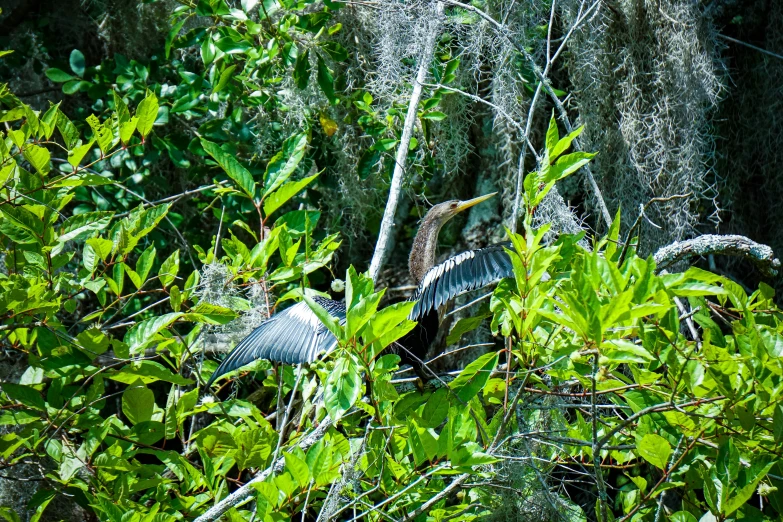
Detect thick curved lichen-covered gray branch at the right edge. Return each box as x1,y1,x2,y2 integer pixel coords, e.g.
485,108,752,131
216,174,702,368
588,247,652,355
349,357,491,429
653,234,780,277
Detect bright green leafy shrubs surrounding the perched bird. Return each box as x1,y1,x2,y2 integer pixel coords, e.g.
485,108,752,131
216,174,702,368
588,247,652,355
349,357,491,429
0,6,783,522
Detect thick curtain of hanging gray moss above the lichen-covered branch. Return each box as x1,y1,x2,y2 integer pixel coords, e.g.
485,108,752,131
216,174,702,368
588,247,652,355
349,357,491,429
564,0,724,252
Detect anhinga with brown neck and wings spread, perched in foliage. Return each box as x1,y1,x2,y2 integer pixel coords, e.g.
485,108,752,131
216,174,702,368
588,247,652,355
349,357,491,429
207,193,513,387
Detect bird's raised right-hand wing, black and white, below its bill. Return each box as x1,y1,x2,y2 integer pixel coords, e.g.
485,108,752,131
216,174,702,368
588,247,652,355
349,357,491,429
409,243,514,321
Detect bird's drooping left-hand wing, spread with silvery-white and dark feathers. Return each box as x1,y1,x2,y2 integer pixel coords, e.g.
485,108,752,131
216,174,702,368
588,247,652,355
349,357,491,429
207,297,345,387
